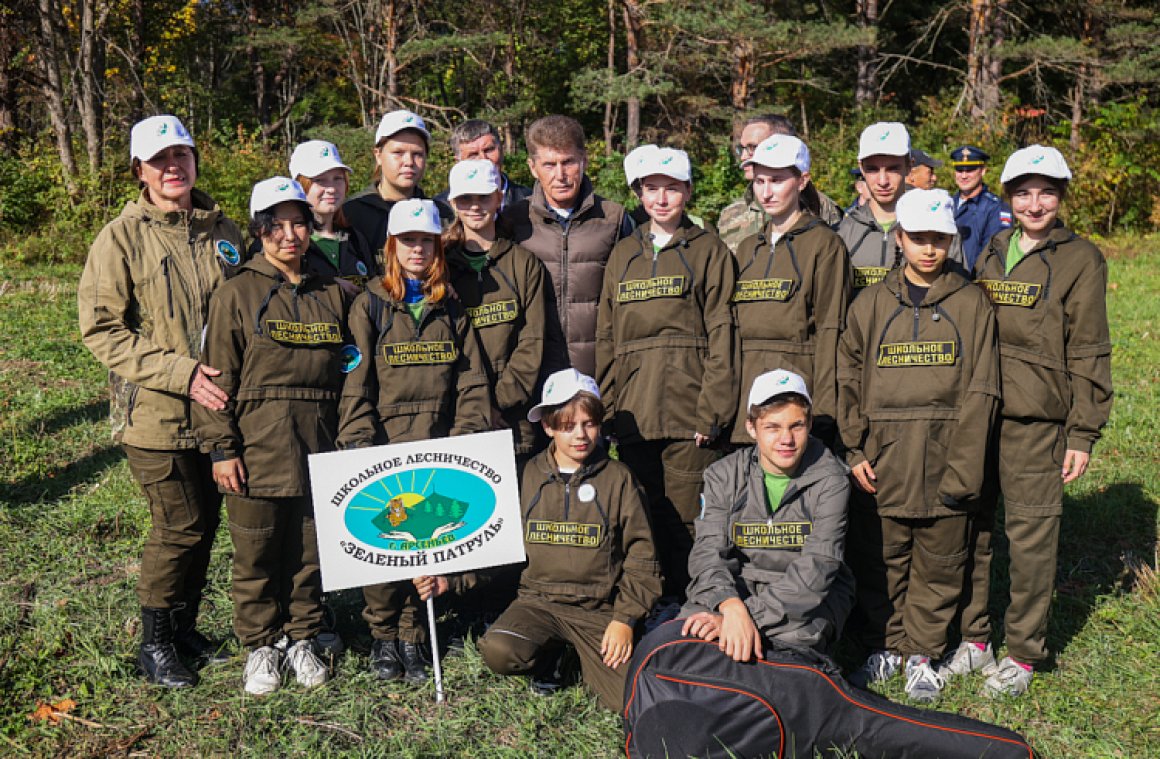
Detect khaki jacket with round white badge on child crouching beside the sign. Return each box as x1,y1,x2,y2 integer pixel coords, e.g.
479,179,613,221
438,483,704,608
520,444,661,627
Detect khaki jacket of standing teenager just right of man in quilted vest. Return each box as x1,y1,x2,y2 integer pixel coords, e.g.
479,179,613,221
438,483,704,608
596,217,738,442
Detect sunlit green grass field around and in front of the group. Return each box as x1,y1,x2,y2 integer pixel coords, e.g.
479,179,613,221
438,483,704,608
0,238,1160,758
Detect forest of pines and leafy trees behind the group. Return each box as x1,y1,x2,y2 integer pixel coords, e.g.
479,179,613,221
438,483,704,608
0,0,1160,262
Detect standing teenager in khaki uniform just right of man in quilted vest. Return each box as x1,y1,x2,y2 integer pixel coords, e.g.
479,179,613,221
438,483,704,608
596,147,738,610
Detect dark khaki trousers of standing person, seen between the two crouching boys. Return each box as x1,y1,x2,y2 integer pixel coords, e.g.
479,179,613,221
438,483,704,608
617,440,720,601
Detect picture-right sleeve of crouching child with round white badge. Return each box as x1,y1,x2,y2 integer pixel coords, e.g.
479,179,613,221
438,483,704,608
612,475,661,627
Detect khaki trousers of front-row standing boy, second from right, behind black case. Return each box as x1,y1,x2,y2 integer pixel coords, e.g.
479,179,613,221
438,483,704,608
847,508,971,658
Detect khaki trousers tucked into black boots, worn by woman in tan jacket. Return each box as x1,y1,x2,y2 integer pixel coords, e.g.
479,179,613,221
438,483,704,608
123,446,222,609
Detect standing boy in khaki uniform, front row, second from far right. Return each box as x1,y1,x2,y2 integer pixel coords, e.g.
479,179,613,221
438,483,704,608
838,189,999,702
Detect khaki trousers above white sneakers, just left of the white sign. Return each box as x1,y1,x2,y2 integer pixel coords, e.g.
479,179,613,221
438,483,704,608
225,496,322,648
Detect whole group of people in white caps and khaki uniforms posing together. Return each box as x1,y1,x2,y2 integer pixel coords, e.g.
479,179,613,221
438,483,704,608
78,110,1111,709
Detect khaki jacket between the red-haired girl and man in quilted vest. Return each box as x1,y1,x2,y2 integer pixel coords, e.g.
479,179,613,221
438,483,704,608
447,240,548,454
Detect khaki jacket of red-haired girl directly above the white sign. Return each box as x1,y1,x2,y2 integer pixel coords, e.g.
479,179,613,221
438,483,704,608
339,279,491,448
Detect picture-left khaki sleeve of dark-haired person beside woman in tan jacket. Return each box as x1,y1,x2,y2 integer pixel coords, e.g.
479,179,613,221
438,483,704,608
189,288,248,461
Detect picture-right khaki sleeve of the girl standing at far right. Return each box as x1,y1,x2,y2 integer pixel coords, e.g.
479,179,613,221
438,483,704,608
1064,251,1112,453
